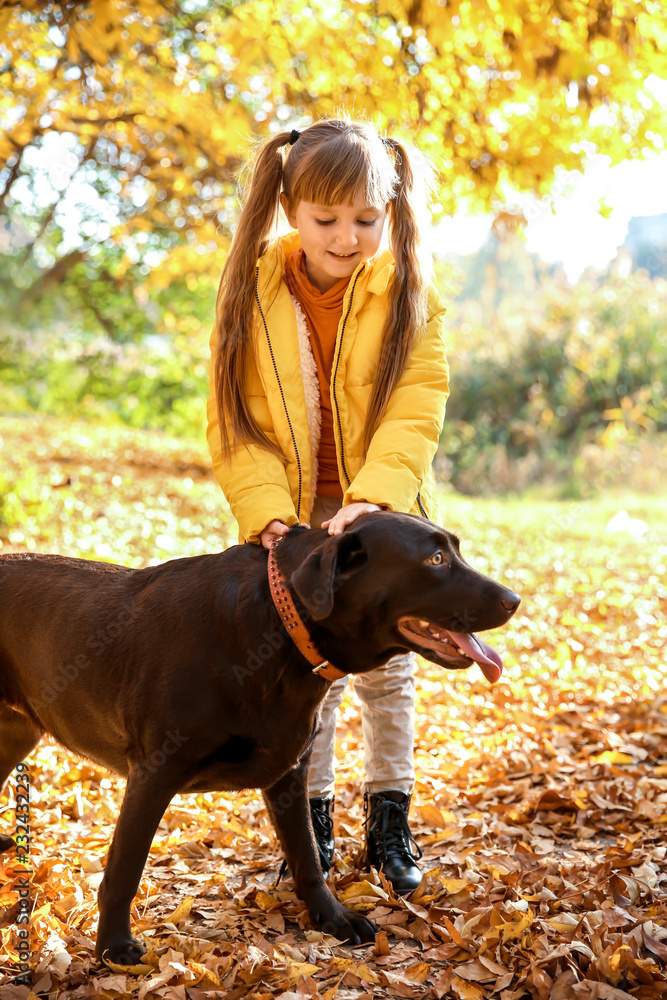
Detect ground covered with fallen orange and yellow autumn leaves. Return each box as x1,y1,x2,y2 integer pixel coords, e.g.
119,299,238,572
0,418,667,1000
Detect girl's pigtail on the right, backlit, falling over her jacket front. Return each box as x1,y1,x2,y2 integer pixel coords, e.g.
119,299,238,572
364,138,428,451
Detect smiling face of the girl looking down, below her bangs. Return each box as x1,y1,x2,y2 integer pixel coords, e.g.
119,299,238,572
280,192,387,292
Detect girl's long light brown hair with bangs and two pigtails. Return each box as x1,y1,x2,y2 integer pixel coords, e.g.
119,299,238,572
215,118,428,457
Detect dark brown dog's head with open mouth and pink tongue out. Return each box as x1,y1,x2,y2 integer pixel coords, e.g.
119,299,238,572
290,512,520,682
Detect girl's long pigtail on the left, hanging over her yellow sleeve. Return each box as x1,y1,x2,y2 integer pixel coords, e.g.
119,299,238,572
215,132,290,459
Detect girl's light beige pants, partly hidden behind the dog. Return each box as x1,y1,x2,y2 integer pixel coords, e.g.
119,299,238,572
308,497,415,798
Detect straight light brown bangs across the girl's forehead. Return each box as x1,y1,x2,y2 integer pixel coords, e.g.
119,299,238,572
286,133,398,208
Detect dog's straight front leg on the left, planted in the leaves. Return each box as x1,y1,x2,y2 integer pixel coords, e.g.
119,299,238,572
96,762,182,965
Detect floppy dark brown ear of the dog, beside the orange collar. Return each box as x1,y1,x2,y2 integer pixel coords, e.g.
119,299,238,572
290,531,368,621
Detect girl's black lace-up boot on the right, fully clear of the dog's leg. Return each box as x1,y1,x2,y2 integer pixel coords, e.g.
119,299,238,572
364,791,422,896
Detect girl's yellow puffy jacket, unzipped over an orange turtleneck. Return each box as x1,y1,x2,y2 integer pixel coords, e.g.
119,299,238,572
207,232,449,542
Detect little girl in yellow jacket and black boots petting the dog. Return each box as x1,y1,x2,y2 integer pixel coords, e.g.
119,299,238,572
207,119,448,893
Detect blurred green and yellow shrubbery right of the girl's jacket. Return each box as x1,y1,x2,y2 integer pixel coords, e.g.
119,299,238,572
441,272,667,491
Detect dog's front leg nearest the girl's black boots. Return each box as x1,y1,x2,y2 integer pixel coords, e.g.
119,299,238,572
262,762,377,944
